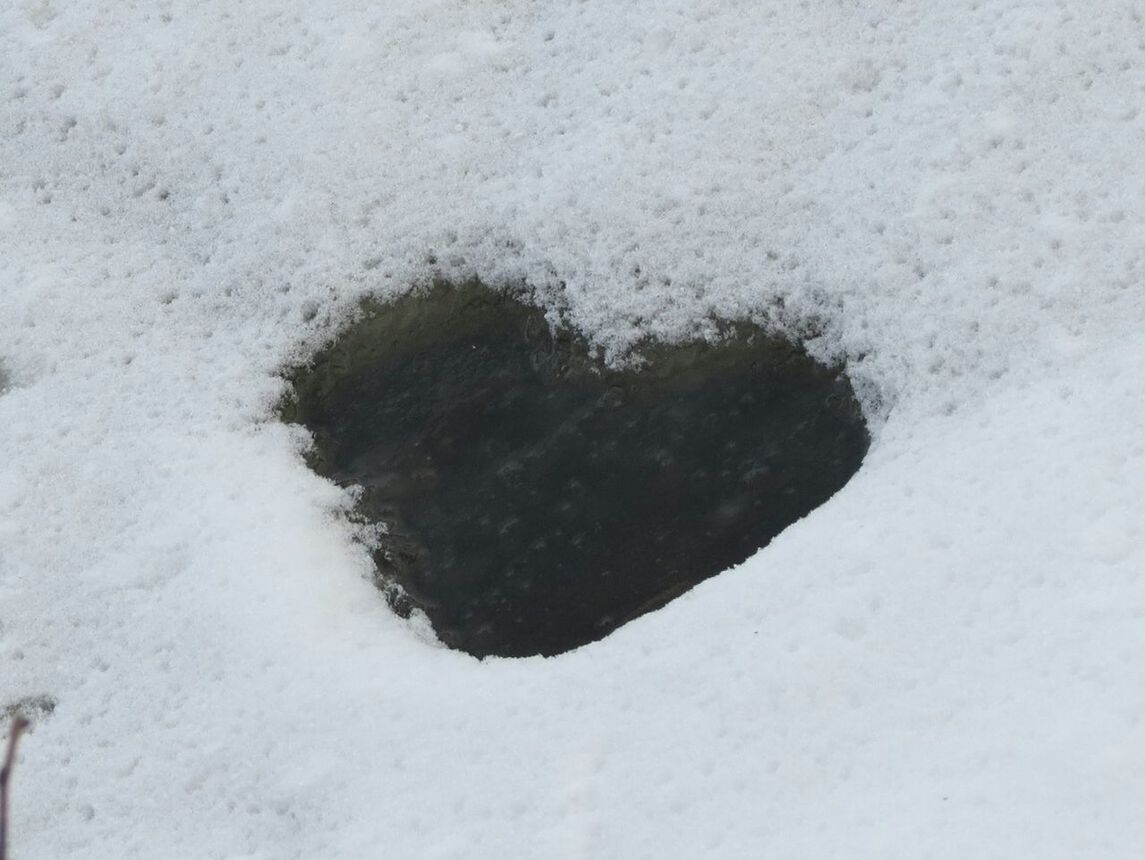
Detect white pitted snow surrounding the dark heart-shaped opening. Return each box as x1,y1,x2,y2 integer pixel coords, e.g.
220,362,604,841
0,0,1145,860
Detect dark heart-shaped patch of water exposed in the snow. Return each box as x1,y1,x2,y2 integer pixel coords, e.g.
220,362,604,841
286,287,869,656
